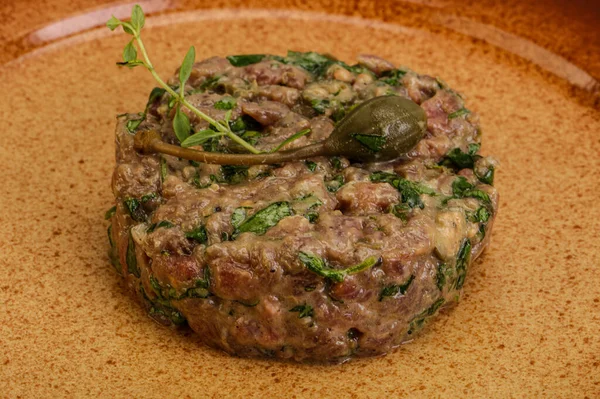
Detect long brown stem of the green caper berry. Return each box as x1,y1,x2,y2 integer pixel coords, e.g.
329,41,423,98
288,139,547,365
134,130,331,165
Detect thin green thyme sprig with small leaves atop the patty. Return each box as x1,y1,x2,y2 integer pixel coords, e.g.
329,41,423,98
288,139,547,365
106,4,260,154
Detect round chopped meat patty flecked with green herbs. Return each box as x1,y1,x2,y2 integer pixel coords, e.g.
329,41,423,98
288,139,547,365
107,52,498,362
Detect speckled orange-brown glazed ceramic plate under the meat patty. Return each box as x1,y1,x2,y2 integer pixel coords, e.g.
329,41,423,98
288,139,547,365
0,0,600,398
